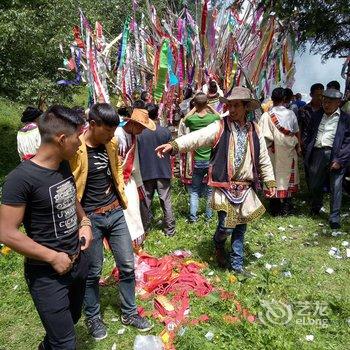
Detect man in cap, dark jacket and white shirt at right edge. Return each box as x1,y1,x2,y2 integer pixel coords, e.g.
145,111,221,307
305,89,350,229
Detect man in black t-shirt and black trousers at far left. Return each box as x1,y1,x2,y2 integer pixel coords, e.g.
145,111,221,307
0,106,92,350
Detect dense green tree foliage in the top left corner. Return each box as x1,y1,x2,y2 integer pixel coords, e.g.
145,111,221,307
0,0,131,103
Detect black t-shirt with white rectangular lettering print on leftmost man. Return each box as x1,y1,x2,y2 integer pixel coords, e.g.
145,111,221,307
2,160,79,255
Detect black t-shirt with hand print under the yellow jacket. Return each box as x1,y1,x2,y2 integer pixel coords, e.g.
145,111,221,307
81,145,117,213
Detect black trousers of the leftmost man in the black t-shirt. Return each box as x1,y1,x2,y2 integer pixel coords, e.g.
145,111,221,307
24,252,88,350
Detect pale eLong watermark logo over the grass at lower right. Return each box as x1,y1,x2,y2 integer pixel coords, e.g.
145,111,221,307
258,300,328,328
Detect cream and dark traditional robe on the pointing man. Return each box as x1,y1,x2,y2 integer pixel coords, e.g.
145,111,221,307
173,117,276,228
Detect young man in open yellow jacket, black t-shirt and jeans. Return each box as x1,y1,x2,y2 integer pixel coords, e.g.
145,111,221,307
70,103,152,340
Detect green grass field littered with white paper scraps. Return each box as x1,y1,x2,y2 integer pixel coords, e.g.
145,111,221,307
0,101,350,350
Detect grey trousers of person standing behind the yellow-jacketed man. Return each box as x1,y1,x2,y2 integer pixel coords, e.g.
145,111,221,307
140,179,175,236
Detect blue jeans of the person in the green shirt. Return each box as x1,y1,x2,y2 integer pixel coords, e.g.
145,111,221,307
189,160,213,222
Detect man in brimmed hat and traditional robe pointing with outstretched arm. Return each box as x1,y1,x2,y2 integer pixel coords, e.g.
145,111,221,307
156,87,276,276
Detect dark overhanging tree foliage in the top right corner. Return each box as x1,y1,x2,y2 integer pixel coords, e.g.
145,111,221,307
268,0,350,59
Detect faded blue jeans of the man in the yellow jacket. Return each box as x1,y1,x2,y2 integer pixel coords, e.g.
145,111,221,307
84,208,137,318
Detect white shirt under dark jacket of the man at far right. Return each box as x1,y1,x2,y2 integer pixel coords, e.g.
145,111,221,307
315,108,340,148
